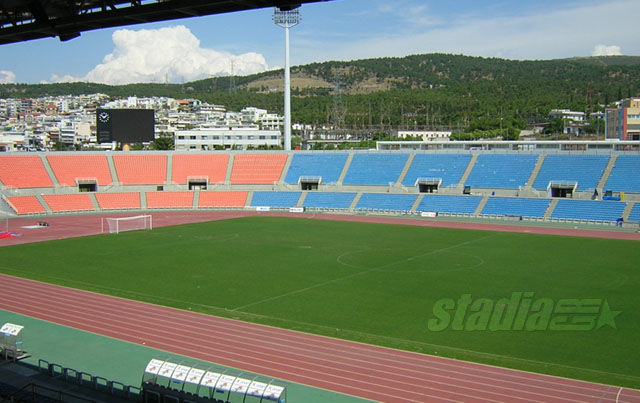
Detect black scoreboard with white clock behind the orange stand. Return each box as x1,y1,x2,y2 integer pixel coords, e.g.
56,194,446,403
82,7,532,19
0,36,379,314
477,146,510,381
96,109,155,143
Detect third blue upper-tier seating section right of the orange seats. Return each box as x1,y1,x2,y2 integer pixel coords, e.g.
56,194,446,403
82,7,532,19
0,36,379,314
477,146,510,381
402,154,471,186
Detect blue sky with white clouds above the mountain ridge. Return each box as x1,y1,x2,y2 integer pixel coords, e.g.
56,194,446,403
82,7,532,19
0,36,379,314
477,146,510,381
0,0,640,84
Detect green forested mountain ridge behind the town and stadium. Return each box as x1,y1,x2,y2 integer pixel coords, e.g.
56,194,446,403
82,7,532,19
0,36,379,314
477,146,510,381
0,54,640,128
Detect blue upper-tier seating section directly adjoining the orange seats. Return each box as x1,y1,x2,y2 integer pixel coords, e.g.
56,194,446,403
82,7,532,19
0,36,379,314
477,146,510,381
284,154,348,184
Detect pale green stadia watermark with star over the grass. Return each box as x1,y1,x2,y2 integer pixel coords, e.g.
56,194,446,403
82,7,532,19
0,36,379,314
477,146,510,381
427,292,620,332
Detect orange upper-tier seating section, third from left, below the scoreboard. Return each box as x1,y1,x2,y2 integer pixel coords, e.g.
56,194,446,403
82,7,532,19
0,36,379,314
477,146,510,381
113,154,167,185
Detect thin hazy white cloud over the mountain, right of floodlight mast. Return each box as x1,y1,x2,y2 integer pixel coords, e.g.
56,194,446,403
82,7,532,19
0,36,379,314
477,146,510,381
303,0,640,60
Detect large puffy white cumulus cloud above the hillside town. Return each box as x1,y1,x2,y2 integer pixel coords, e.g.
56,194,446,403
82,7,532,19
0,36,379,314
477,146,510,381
52,25,268,84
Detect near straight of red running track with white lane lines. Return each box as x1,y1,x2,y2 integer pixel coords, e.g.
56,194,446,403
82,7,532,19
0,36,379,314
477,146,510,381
0,274,640,402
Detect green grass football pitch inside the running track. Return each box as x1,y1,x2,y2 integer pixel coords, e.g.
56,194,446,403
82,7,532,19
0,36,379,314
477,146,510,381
0,217,640,388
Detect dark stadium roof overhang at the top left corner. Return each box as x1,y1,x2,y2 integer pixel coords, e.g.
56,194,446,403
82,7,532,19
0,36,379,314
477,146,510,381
0,0,330,45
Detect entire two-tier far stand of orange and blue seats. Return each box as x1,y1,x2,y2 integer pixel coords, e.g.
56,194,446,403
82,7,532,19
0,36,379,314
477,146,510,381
0,151,640,230
